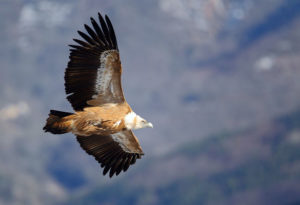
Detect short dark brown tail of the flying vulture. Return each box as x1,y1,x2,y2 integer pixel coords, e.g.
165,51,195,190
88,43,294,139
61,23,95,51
43,110,73,134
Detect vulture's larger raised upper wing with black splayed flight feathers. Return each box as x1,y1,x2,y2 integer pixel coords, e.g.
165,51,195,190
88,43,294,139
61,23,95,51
65,13,125,111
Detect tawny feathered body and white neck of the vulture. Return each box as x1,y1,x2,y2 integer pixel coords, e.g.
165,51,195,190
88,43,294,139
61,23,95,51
49,102,149,136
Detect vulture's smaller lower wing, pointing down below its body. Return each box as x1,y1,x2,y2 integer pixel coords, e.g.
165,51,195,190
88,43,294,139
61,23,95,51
77,130,144,177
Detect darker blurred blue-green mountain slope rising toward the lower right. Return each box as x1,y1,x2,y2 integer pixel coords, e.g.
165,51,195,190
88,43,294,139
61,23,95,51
66,111,300,204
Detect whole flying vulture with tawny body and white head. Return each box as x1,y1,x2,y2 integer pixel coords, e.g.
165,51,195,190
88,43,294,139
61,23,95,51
43,13,153,177
